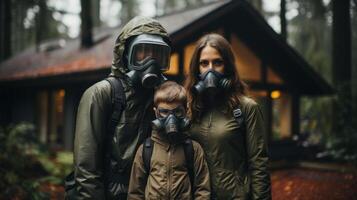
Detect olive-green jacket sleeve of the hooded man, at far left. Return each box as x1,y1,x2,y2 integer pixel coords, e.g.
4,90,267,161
74,81,111,199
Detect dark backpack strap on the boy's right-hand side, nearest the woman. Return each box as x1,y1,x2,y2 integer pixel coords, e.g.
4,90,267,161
183,138,195,196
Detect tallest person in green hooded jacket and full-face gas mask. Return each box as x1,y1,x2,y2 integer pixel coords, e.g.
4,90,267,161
74,17,170,200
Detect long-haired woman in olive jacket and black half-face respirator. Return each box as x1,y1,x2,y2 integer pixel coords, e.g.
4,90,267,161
185,34,271,200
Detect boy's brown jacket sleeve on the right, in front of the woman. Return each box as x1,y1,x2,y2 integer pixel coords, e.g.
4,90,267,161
192,141,211,200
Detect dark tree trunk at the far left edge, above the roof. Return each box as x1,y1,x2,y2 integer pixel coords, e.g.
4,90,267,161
0,0,11,61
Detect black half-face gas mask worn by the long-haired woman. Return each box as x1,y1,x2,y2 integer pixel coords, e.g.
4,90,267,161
193,69,232,94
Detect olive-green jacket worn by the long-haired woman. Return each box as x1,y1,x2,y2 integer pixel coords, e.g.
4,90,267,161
189,96,271,200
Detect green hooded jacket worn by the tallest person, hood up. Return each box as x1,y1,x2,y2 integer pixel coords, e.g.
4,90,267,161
74,17,170,200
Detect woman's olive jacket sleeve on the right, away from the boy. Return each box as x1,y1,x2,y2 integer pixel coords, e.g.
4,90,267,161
245,101,271,199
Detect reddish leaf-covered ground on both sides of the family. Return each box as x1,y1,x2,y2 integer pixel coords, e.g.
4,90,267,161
42,168,357,200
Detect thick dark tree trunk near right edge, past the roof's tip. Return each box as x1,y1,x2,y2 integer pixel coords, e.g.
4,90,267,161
332,0,352,133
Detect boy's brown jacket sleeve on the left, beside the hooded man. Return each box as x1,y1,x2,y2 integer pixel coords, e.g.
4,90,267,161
128,145,148,200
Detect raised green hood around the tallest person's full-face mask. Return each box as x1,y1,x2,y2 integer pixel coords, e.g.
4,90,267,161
112,16,171,76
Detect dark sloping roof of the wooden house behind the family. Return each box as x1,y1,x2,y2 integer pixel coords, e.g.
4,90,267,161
0,0,332,94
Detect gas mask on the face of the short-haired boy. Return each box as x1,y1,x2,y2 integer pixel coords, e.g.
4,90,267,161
152,106,190,138
